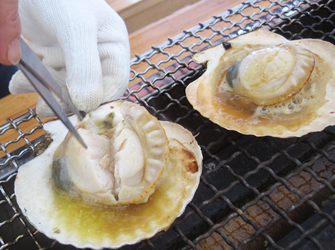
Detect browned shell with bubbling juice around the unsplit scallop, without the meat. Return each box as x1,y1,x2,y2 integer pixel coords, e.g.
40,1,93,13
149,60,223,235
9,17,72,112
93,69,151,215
186,28,335,138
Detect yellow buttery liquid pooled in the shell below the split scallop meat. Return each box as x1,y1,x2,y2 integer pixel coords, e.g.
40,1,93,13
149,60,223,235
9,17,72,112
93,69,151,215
50,145,198,246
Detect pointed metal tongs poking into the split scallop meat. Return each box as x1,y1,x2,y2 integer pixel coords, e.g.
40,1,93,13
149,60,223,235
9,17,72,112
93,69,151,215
17,38,87,148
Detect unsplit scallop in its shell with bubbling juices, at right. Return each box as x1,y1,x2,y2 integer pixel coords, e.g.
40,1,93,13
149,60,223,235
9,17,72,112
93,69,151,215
186,28,335,138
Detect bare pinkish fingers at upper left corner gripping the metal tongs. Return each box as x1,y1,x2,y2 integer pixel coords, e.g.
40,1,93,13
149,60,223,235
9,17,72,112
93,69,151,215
0,0,21,65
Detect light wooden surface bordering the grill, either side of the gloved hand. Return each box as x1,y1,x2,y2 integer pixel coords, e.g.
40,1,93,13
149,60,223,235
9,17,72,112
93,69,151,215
0,0,241,157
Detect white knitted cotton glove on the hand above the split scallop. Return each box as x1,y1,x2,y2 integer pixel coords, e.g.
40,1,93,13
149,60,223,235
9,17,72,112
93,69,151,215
9,0,130,116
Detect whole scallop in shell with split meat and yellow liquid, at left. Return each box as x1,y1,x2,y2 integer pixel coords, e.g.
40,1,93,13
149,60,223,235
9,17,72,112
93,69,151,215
15,101,202,249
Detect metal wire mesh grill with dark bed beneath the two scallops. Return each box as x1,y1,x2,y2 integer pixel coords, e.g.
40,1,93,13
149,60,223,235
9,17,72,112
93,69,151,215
0,0,335,250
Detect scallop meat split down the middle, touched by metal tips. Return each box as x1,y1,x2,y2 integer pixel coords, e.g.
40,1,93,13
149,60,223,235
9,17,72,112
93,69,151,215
52,102,168,205
